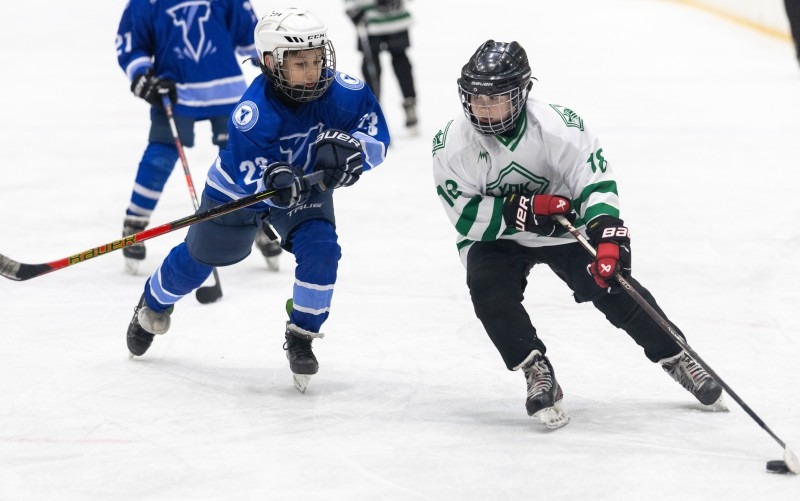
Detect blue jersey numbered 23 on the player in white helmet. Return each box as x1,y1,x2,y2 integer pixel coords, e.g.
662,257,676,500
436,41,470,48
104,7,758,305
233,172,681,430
206,72,390,205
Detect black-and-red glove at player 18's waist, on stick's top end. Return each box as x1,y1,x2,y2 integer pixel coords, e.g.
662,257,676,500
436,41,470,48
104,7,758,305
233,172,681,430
503,193,577,237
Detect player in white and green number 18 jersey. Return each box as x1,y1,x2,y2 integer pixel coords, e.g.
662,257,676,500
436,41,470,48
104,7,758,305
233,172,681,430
433,40,723,428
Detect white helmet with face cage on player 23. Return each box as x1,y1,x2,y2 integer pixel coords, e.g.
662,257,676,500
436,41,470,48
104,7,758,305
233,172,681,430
255,7,336,102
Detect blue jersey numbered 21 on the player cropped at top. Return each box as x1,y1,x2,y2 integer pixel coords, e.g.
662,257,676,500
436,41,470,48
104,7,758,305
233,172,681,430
116,0,258,119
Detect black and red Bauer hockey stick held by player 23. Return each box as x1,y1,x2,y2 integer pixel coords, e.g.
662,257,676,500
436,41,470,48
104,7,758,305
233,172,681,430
0,171,324,281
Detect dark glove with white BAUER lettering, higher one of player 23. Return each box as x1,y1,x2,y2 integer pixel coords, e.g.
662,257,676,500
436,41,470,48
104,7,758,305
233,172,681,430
314,129,364,190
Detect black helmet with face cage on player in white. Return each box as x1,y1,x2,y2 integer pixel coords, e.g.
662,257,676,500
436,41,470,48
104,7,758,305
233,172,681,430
458,40,533,135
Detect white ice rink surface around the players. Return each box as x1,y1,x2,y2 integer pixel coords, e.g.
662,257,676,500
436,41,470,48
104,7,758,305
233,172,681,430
0,0,800,501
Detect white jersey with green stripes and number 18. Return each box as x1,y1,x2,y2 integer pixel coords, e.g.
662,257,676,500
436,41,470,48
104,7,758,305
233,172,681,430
433,97,619,266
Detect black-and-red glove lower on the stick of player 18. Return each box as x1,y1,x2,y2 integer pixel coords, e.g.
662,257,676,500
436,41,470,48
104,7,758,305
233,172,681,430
586,216,631,294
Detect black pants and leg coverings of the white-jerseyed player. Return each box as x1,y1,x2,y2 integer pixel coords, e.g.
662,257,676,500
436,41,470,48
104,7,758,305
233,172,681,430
467,240,683,369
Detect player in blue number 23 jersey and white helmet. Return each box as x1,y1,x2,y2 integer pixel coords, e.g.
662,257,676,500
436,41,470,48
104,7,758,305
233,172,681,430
127,8,389,391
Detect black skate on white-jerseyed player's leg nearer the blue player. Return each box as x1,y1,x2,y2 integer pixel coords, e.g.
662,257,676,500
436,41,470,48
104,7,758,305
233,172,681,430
522,350,569,429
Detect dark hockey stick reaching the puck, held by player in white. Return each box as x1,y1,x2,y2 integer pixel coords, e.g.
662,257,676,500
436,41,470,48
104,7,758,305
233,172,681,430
553,215,800,474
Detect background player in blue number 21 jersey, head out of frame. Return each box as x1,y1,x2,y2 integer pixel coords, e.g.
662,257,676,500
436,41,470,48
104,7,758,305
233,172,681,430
117,0,280,273
